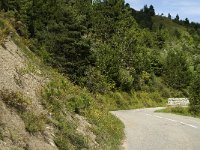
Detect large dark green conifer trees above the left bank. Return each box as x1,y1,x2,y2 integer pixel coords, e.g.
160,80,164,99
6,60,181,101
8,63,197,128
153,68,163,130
19,0,91,82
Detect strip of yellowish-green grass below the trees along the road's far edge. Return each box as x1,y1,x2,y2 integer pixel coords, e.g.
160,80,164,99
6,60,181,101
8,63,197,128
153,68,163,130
96,91,166,110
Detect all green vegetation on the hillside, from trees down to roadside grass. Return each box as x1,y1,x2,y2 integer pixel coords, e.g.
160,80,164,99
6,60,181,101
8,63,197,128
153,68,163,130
0,0,200,150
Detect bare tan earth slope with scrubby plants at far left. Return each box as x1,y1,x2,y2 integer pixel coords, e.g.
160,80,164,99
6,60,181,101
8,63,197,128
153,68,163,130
0,38,57,150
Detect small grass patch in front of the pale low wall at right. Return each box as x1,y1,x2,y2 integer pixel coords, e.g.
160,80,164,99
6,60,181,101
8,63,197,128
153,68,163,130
156,106,200,118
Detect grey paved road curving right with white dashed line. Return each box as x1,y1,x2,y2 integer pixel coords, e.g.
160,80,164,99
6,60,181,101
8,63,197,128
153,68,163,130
112,108,200,150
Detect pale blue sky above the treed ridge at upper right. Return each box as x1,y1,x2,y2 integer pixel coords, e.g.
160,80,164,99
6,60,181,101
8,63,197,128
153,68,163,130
125,0,200,23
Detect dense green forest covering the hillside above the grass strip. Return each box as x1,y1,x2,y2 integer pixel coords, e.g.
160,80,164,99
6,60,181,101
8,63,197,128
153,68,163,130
0,0,200,93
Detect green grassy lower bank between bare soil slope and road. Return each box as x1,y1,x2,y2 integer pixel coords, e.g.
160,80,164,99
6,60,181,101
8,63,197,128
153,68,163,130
42,74,124,150
